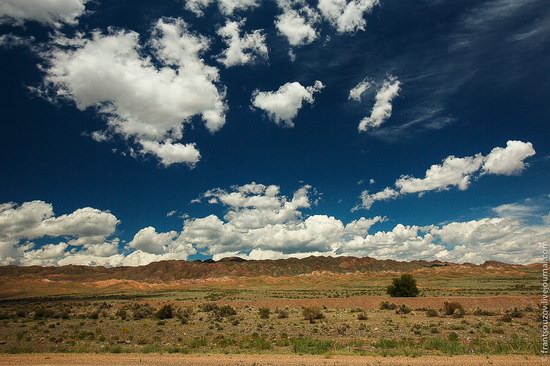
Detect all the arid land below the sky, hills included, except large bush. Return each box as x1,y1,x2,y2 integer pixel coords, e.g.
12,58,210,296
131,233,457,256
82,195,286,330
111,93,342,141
0,258,542,365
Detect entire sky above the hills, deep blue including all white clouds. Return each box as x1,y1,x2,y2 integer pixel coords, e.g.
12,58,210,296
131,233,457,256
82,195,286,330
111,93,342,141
0,0,550,265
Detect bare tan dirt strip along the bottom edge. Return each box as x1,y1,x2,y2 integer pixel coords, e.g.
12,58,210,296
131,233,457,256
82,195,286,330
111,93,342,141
0,354,548,366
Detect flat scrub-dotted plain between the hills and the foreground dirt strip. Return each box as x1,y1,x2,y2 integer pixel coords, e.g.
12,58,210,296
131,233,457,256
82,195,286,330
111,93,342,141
0,266,540,356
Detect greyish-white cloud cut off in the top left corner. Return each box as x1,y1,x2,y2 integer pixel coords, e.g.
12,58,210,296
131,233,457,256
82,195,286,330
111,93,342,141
0,0,88,27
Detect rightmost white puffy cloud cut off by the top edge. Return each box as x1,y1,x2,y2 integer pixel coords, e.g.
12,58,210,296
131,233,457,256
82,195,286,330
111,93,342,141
317,0,380,33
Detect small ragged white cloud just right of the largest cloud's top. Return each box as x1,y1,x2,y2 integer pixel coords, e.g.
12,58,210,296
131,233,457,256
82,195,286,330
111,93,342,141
218,20,268,67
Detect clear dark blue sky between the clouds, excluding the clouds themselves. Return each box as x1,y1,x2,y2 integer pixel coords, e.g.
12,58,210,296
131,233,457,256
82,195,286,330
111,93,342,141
0,0,550,249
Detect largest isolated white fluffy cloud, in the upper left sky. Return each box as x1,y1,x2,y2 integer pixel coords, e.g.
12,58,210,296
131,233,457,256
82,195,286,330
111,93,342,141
37,18,226,165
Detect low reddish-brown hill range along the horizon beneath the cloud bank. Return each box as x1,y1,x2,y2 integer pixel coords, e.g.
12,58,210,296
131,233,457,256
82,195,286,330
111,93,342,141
0,256,518,283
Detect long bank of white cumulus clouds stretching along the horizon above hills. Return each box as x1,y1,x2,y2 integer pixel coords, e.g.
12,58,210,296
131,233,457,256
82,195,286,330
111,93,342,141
0,182,550,267
